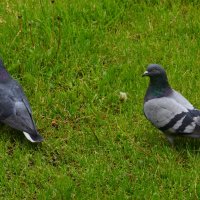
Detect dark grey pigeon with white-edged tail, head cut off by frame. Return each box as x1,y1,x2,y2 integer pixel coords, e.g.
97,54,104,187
0,60,43,142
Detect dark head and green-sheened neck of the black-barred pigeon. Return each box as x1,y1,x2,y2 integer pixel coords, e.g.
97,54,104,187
143,64,172,100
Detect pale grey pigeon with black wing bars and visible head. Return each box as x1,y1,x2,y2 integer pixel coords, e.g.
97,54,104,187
143,64,200,145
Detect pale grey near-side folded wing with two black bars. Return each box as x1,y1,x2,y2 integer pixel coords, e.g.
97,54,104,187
144,97,196,134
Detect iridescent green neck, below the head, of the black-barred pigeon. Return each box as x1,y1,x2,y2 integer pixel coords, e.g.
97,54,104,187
145,77,172,101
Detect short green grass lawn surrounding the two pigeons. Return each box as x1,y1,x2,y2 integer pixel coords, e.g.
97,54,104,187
0,0,200,200
